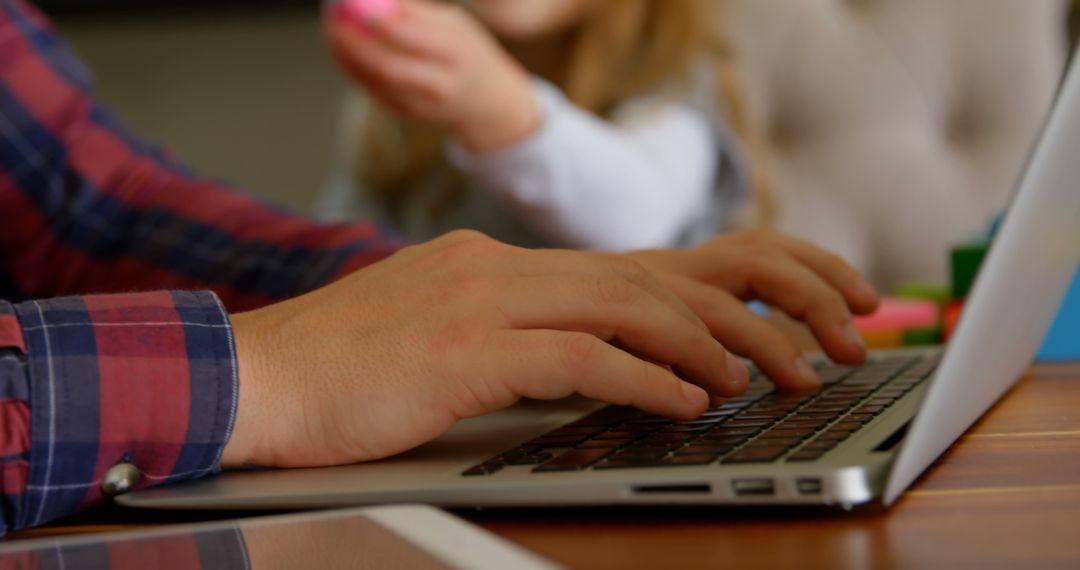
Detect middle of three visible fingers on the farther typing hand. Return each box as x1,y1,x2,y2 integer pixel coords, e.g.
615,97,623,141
734,252,866,363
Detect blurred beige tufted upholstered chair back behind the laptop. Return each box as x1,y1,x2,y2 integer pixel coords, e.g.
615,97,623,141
724,0,1066,288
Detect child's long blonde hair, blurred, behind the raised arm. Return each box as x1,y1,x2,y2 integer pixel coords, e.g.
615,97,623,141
356,0,772,222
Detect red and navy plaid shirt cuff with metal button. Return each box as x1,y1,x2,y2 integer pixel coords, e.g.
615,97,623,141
15,291,239,527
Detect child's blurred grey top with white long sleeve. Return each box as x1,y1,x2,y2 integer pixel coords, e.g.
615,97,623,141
319,81,744,250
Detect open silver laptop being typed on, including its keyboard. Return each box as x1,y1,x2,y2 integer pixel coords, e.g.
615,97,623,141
118,50,1080,508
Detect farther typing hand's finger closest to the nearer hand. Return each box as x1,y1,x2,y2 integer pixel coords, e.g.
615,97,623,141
664,275,821,390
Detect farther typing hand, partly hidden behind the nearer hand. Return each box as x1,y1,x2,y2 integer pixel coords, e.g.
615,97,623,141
631,230,878,390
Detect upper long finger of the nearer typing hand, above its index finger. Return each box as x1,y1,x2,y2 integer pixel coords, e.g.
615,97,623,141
495,274,747,396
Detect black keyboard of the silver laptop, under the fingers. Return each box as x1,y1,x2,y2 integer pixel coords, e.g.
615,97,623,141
462,355,939,476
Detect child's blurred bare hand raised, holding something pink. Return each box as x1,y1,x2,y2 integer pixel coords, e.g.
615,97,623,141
327,0,539,152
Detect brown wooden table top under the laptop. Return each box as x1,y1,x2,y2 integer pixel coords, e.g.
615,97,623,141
11,365,1080,570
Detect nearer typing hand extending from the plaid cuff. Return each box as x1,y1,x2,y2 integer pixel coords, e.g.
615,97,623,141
221,232,747,466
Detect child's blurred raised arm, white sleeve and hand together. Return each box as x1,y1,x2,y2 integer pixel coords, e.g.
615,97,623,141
328,1,740,249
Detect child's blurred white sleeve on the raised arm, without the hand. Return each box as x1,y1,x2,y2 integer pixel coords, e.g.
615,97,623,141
449,83,720,249
